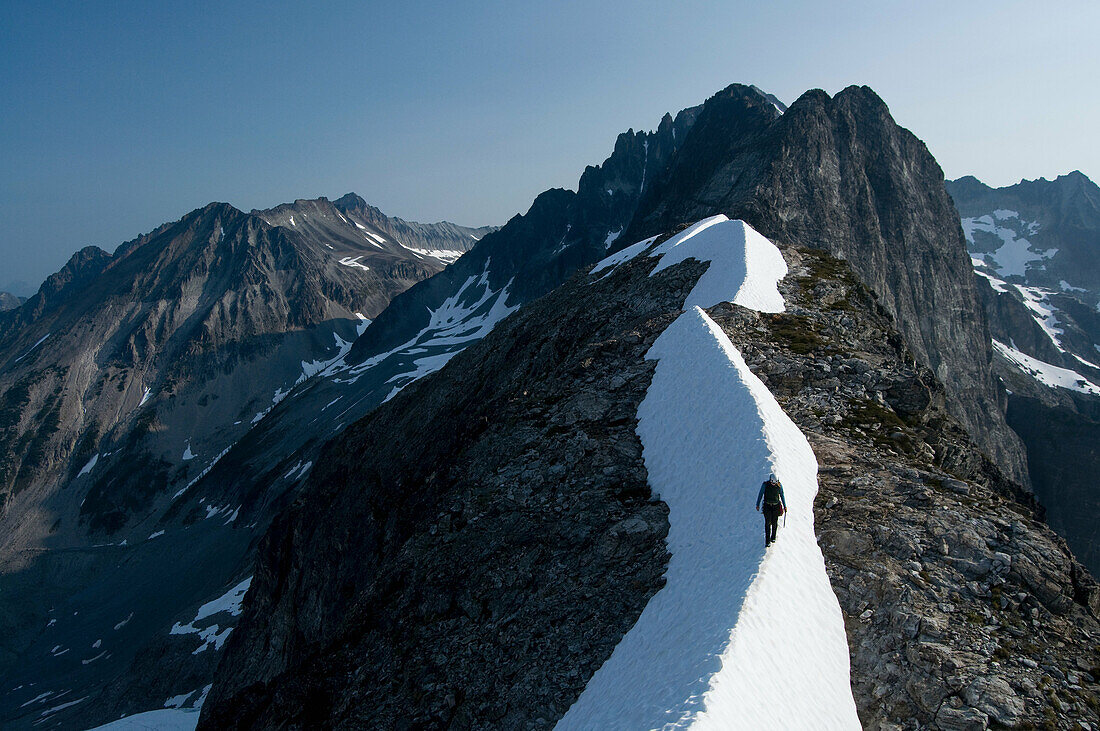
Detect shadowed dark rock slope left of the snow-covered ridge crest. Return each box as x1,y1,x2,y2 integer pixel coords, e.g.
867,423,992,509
204,249,702,728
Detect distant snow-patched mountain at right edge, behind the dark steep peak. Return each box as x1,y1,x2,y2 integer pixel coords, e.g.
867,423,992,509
947,171,1100,573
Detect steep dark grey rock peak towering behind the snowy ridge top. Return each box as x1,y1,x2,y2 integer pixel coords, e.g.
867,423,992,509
626,85,1027,484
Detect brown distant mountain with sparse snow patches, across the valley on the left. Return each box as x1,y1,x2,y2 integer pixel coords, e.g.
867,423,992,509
0,195,491,715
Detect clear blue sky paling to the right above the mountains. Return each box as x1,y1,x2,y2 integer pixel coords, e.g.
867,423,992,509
0,0,1100,289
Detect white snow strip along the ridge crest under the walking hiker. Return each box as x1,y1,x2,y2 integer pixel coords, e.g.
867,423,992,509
558,215,860,729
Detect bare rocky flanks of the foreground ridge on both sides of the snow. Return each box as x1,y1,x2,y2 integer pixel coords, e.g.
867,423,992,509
200,248,1100,728
